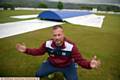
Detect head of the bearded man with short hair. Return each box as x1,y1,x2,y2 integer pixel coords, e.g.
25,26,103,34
52,25,64,46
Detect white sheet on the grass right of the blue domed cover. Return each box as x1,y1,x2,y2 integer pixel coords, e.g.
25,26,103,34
64,14,105,28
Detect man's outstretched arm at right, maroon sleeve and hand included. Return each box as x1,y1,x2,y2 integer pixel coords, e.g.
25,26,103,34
72,46,100,69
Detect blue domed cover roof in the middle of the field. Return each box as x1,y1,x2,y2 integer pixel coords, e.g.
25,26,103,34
38,11,91,21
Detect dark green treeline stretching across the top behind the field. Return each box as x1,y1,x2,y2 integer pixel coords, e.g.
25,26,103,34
0,0,120,12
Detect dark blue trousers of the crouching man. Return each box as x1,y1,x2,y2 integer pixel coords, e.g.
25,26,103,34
36,61,78,80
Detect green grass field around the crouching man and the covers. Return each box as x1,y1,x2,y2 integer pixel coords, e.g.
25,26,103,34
0,11,120,80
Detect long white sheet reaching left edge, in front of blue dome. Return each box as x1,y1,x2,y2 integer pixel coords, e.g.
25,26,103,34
0,19,63,38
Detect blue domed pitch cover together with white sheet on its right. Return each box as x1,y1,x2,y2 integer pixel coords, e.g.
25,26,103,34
38,10,105,28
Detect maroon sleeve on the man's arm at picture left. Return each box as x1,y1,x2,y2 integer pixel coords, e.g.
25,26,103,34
25,42,46,56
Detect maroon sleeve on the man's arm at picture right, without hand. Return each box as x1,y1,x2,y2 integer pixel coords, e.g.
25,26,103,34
72,45,91,69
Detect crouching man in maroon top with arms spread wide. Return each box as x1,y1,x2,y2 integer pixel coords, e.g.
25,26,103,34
16,25,100,80
